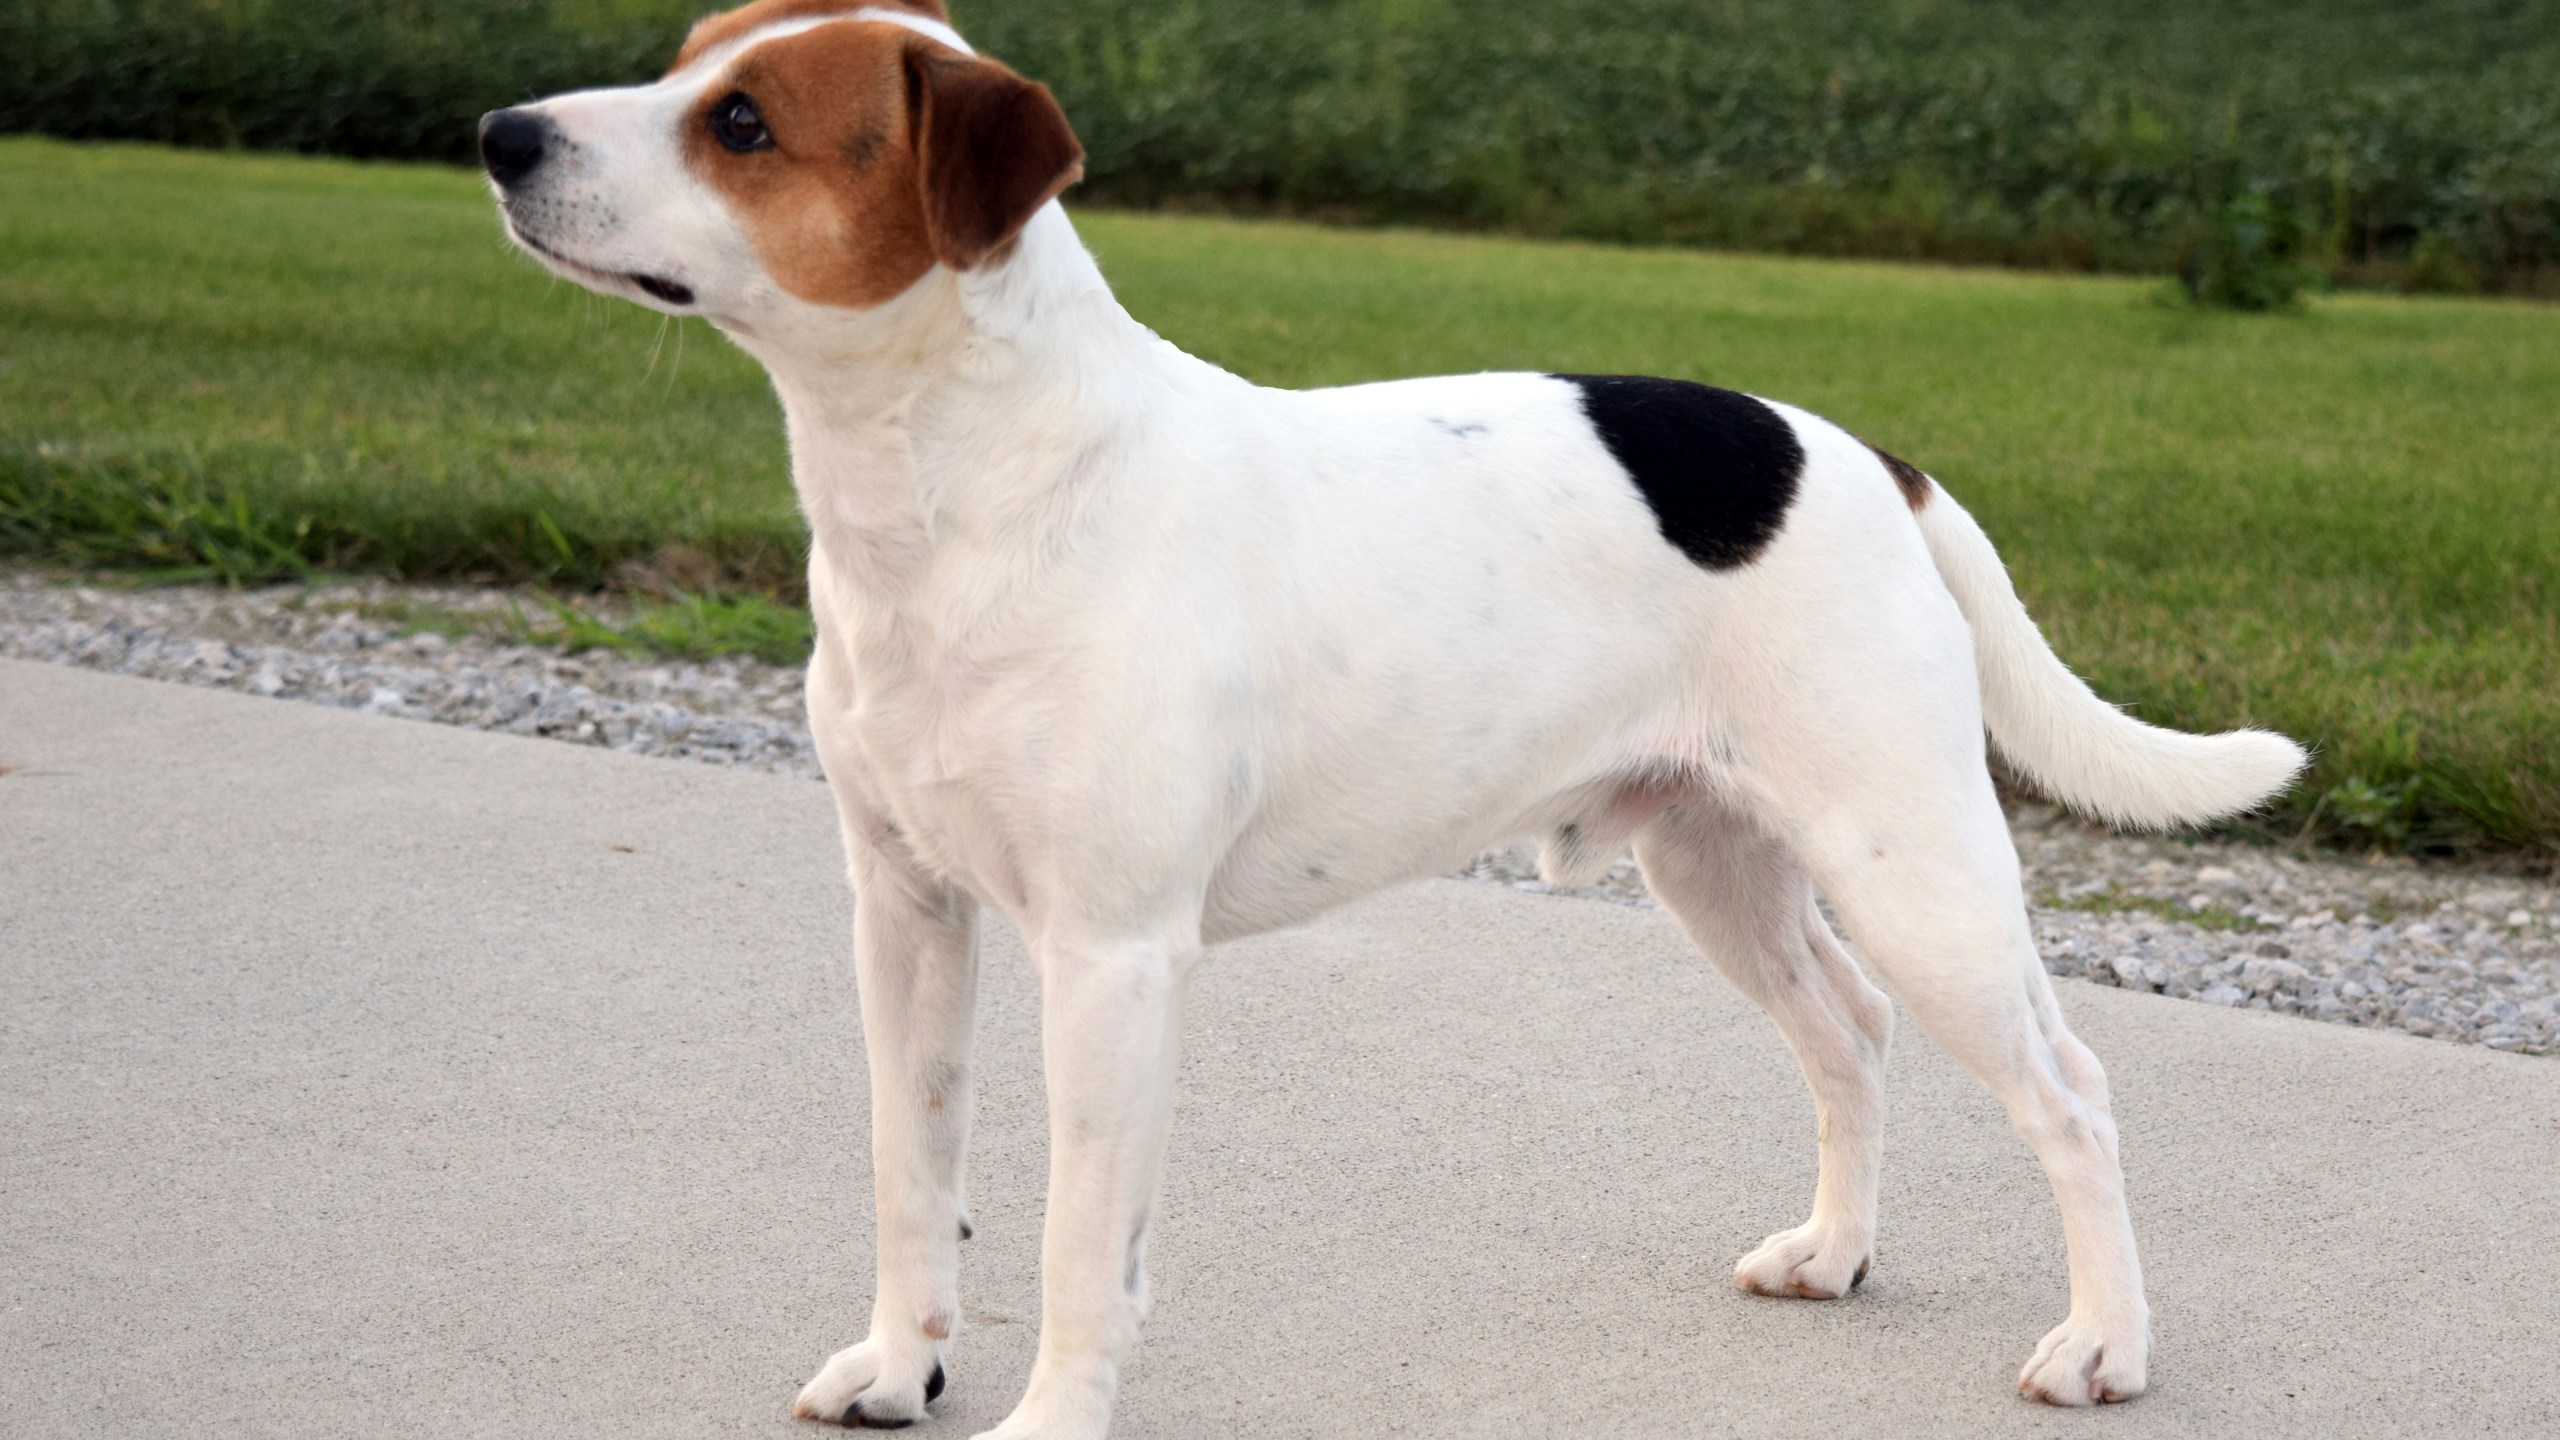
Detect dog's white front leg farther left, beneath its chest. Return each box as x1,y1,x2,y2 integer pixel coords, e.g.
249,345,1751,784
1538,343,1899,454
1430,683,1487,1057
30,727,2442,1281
791,850,978,1427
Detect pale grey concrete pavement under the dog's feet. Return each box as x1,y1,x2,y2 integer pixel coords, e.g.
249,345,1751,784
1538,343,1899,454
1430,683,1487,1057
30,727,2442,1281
0,661,2560,1440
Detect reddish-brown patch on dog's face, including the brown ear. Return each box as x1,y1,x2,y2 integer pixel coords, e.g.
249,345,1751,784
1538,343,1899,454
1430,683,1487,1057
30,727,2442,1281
684,20,1083,307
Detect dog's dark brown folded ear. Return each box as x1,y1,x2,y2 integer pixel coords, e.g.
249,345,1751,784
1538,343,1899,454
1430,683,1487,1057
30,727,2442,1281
906,44,1085,269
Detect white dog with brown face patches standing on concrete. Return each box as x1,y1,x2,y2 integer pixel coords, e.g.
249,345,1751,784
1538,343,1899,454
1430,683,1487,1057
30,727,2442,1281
479,0,2304,1440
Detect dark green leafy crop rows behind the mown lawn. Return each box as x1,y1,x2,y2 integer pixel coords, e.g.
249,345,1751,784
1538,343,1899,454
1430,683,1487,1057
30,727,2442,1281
0,0,2560,292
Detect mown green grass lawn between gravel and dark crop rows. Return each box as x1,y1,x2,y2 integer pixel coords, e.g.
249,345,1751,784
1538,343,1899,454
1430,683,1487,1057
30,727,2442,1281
0,141,2560,858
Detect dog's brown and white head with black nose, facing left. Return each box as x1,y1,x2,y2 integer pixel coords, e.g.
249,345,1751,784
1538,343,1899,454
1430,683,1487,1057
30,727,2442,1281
479,0,1083,325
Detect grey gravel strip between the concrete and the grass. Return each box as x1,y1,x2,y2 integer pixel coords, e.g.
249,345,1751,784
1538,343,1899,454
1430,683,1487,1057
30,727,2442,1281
0,571,2560,1056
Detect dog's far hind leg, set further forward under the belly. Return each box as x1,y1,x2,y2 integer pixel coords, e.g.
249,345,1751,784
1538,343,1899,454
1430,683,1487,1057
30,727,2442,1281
1636,799,1894,1299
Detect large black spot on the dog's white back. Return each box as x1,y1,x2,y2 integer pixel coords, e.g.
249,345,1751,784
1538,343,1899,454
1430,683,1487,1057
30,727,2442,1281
1556,374,1805,569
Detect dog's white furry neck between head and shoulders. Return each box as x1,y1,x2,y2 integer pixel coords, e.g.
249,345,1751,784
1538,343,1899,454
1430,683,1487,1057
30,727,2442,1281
737,205,1172,612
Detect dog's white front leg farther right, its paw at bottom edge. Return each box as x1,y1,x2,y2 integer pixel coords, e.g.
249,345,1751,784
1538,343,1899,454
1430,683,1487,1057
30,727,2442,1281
978,922,1198,1440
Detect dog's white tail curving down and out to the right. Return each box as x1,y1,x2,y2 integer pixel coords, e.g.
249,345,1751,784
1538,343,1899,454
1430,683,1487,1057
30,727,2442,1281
1917,487,2307,828
